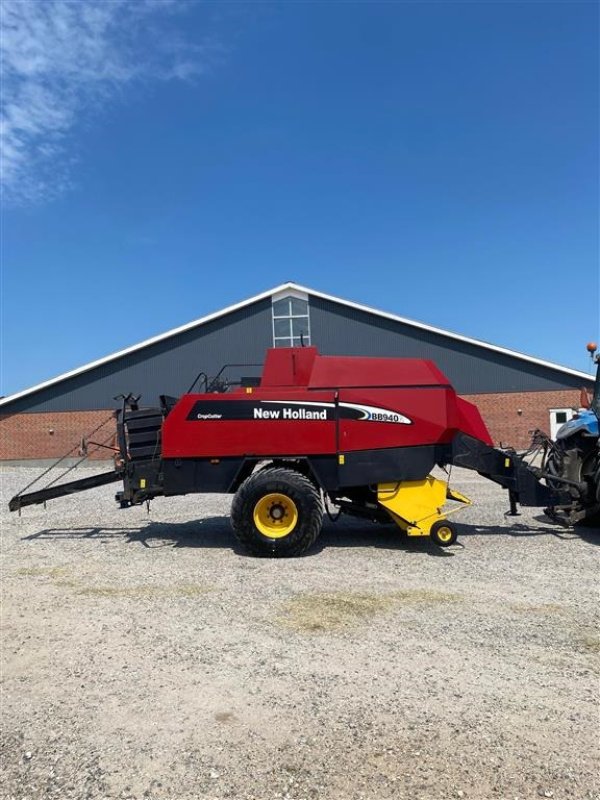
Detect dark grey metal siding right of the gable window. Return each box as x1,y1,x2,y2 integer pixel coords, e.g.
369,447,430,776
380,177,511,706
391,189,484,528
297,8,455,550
310,297,591,394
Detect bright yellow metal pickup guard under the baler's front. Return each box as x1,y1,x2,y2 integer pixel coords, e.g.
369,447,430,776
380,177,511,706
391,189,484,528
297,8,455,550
377,475,471,536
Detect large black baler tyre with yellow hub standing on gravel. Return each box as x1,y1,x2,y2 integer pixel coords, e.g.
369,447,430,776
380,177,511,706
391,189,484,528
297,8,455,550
231,467,323,558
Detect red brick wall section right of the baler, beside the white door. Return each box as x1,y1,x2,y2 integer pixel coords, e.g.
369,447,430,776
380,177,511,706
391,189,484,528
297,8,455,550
464,389,580,449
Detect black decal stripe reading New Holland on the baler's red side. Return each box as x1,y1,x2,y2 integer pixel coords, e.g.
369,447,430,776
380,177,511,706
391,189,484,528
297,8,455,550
187,399,412,425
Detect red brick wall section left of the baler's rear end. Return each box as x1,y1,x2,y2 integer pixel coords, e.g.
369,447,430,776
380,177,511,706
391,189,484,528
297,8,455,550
0,409,117,460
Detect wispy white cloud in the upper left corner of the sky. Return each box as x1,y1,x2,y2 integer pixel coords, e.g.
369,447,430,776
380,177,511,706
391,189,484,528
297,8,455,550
0,0,207,204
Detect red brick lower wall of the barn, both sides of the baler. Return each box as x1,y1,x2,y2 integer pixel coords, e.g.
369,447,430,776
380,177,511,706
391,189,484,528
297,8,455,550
0,389,579,460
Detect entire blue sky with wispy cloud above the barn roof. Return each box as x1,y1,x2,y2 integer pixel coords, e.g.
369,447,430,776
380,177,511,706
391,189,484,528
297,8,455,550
1,0,600,394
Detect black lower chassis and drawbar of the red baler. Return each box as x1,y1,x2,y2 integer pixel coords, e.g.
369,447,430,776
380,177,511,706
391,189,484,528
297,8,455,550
116,433,578,516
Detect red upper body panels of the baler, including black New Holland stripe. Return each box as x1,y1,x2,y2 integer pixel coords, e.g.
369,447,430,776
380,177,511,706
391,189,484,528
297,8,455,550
161,347,492,459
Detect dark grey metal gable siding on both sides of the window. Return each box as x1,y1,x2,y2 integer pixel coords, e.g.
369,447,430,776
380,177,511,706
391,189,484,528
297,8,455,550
1,296,591,414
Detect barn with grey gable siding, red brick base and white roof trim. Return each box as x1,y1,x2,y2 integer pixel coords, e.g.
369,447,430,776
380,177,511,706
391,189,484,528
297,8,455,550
0,282,592,461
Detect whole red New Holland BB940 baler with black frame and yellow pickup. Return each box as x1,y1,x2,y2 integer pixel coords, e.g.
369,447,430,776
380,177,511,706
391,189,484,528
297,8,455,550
9,347,581,557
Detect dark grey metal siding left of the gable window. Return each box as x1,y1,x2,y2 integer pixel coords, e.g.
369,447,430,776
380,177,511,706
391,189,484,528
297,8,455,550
1,299,272,414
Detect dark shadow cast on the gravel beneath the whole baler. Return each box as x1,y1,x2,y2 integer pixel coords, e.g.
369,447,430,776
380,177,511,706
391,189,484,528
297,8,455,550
22,517,600,558
